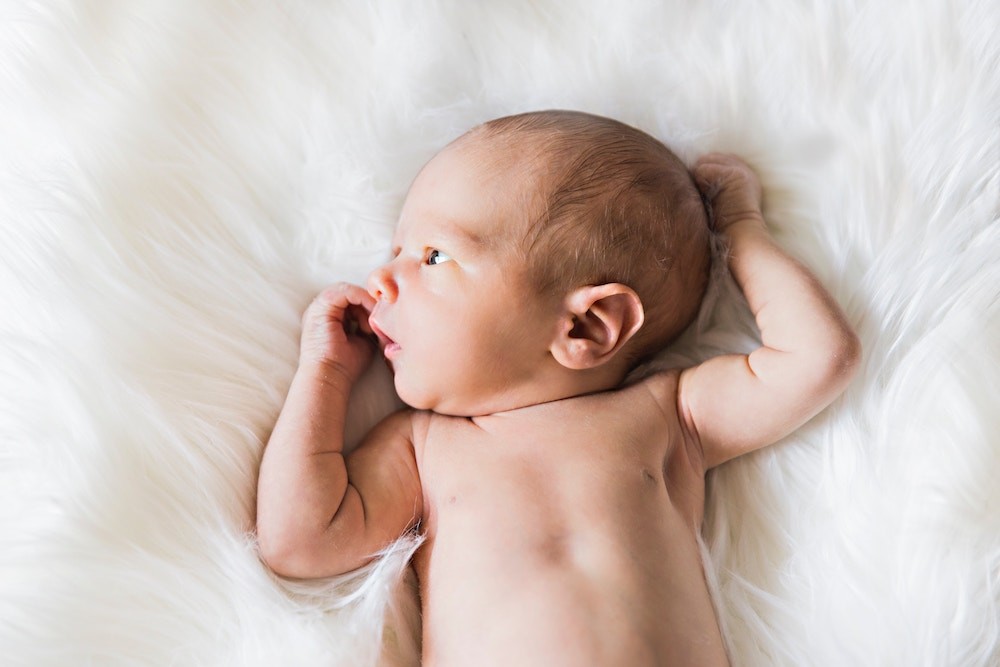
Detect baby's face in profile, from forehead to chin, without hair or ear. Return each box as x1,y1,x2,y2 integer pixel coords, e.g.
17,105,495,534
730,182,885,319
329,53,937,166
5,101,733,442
368,142,555,416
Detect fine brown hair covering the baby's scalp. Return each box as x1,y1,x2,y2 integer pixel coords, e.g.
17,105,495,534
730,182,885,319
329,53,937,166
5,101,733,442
470,111,710,366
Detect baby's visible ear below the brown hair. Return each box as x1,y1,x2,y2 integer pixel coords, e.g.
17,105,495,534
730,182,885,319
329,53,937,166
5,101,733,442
549,283,644,370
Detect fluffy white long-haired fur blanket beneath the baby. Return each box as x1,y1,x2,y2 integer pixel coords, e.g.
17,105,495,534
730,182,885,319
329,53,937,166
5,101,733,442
0,0,1000,666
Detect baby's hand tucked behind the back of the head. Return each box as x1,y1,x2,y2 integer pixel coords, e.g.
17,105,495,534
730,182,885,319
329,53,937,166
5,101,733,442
692,153,766,232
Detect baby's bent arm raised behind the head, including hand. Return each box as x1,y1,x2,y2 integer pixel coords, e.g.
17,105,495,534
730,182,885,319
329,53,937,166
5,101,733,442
678,154,861,468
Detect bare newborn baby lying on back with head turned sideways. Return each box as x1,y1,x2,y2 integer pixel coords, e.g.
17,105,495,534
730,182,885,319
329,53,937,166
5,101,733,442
257,111,860,667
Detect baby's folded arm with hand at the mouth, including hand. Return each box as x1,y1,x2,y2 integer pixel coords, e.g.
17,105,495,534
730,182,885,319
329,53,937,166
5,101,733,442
257,284,422,578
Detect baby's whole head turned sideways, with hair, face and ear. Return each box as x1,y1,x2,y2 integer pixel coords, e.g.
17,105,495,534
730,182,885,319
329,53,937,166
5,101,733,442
370,111,710,414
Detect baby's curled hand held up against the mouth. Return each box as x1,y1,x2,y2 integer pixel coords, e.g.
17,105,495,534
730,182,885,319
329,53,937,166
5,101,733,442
299,283,375,382
